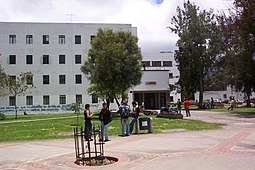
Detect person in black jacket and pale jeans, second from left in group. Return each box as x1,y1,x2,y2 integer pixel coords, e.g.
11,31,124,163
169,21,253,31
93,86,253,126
99,103,112,142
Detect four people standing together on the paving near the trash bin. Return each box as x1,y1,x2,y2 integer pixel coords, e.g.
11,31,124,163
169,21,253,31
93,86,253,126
84,99,140,142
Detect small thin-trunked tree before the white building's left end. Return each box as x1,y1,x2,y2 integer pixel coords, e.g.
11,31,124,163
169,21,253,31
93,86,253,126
3,72,34,119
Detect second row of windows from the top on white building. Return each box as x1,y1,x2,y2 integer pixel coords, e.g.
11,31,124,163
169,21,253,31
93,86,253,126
8,55,81,64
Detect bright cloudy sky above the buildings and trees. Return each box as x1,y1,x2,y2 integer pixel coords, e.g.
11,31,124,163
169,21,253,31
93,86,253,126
0,0,232,53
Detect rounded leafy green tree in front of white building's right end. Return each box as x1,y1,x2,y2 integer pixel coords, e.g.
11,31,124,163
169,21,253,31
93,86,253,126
81,29,142,106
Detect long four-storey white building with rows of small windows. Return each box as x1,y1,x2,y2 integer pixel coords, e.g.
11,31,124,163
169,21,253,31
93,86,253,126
0,22,137,112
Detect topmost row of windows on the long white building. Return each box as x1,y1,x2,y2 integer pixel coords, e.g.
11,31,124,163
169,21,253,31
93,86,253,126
9,35,95,44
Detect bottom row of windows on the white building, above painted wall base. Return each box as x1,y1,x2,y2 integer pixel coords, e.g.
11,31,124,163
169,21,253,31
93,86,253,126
9,94,98,106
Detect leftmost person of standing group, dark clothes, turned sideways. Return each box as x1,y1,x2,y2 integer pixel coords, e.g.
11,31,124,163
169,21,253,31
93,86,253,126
84,104,92,141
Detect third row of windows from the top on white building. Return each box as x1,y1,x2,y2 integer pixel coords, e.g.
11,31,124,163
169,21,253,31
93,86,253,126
10,74,82,85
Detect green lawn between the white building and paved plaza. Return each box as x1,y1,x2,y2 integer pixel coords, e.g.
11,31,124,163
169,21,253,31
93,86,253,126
0,113,222,142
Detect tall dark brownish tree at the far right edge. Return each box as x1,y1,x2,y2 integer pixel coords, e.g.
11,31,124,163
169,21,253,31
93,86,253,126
219,0,255,106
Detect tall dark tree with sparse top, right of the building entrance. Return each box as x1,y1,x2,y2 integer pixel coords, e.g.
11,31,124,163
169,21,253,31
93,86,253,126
169,1,221,107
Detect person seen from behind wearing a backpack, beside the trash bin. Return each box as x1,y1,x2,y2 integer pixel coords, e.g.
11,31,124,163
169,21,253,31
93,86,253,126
119,99,130,136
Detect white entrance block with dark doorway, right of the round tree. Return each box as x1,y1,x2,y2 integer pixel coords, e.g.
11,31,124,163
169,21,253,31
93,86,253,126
129,52,181,109
